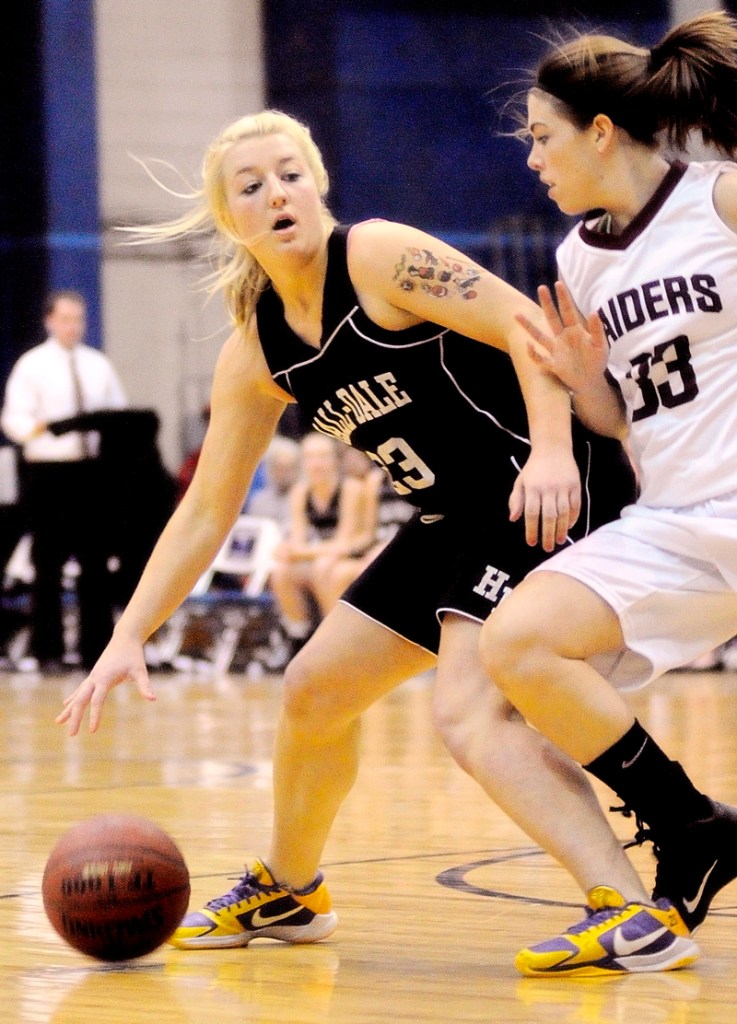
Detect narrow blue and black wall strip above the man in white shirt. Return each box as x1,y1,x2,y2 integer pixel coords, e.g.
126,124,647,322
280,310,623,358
0,0,102,432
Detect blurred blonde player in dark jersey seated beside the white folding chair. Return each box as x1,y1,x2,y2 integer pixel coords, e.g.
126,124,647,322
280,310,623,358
269,433,363,657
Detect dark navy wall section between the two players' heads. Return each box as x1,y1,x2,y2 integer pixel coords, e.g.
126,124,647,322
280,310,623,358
264,0,668,284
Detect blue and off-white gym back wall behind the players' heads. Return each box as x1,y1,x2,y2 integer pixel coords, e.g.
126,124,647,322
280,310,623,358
0,0,671,470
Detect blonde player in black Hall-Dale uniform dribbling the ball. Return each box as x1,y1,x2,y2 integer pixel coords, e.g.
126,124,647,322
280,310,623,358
58,112,651,970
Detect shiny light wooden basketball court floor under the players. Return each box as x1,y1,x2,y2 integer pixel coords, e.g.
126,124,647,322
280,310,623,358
0,659,737,1024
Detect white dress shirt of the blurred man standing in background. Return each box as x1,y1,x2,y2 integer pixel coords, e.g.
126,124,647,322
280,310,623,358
0,337,128,462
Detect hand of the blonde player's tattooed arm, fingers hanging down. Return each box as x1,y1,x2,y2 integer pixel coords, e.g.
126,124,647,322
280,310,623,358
509,450,581,551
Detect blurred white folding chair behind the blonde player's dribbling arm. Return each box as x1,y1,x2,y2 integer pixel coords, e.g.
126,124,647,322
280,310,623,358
149,514,281,674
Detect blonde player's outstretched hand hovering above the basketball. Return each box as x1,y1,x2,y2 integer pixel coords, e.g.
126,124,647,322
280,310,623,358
55,637,157,736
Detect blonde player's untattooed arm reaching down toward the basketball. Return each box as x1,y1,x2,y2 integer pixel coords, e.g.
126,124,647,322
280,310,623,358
56,323,285,735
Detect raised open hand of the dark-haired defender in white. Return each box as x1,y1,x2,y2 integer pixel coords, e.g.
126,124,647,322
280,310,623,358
516,281,609,395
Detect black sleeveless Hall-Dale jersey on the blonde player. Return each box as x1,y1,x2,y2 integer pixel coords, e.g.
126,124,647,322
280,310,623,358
256,226,634,523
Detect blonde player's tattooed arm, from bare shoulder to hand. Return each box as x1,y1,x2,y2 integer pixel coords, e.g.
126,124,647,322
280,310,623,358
349,221,580,551
